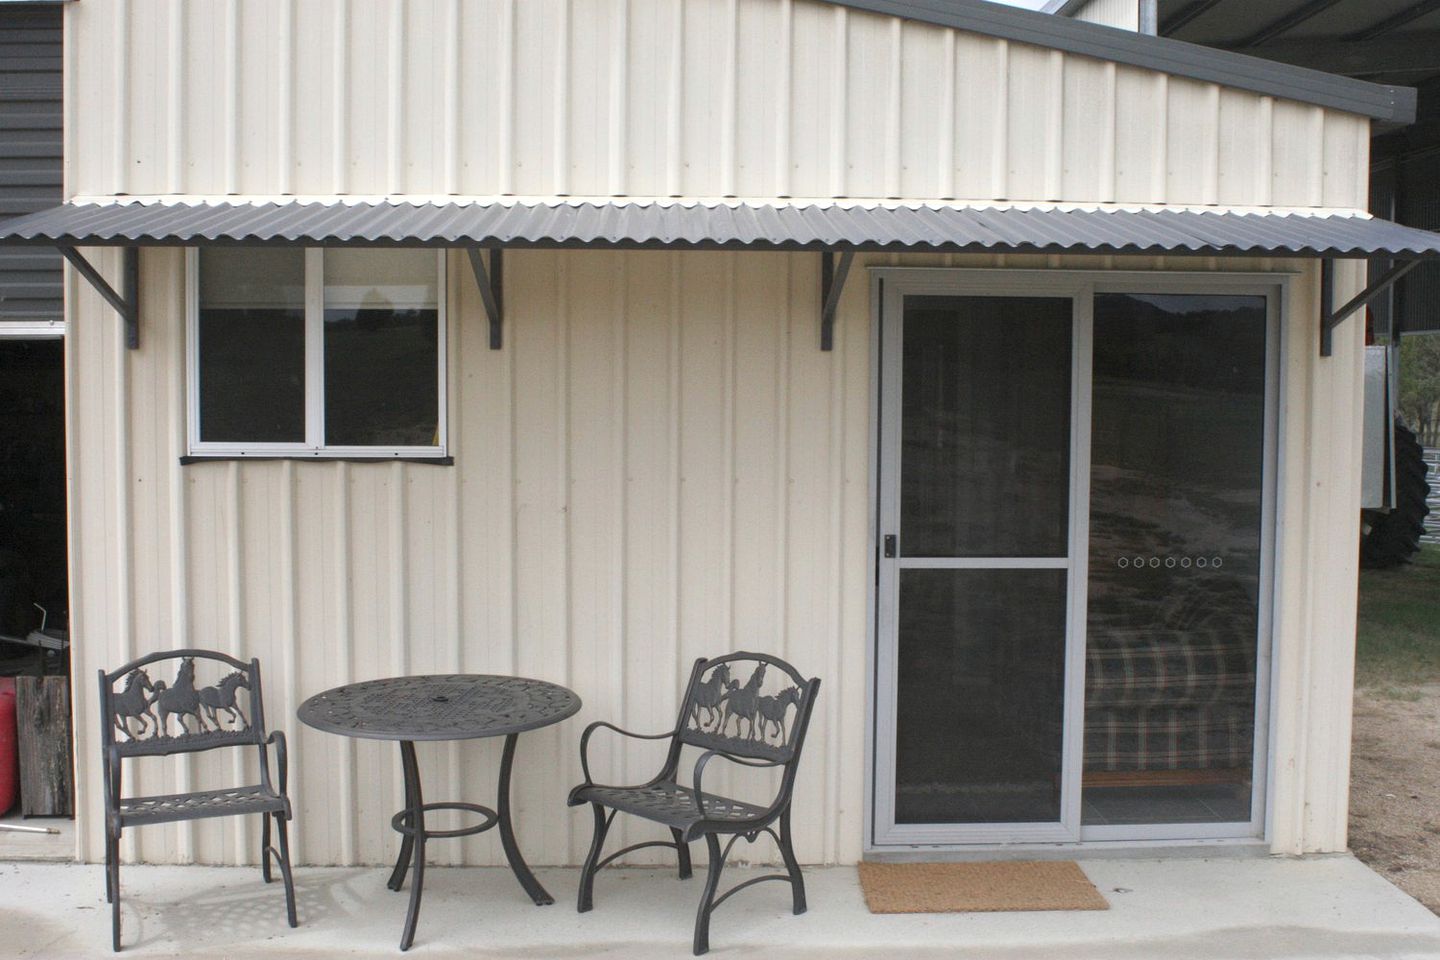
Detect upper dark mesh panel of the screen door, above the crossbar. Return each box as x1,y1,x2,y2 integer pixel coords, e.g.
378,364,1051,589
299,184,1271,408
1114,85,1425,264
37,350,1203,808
900,296,1071,557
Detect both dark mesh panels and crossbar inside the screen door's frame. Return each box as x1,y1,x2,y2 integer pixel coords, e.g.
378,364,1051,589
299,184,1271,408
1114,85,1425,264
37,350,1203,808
894,296,1073,823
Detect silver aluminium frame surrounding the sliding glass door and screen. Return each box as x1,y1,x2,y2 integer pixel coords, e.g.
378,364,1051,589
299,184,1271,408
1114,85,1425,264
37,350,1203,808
861,266,1296,856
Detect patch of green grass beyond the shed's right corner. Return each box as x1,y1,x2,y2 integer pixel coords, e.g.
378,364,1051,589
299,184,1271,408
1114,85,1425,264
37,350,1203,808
1355,545,1440,687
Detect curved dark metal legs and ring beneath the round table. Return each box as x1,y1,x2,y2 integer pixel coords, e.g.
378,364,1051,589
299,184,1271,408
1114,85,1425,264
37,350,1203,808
386,734,554,950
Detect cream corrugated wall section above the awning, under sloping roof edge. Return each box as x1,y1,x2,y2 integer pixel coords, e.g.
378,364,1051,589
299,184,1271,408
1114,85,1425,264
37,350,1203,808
68,0,1369,206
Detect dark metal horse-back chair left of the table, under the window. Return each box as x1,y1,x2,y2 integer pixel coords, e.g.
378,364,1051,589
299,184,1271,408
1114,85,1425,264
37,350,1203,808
99,651,297,950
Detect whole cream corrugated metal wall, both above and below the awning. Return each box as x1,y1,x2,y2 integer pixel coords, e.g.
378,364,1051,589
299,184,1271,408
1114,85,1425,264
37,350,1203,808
66,0,1368,864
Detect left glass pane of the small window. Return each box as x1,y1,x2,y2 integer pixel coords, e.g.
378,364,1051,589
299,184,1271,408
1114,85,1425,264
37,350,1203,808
196,249,305,443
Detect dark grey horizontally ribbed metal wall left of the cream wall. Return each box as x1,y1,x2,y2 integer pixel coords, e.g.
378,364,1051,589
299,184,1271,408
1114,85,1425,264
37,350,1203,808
0,3,63,321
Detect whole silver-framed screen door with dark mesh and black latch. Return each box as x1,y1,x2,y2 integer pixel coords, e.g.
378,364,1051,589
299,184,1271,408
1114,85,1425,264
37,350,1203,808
873,278,1089,843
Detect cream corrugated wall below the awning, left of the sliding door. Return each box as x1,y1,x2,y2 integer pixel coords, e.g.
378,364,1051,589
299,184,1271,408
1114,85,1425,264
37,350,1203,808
72,250,870,864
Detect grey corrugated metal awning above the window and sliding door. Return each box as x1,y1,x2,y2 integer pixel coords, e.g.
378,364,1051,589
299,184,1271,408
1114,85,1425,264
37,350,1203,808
0,197,1440,258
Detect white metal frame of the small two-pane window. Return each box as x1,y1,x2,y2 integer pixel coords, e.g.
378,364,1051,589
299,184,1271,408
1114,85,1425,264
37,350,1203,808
184,246,449,461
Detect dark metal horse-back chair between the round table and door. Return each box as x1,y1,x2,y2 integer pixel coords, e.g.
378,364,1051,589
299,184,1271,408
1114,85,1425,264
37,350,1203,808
569,653,819,956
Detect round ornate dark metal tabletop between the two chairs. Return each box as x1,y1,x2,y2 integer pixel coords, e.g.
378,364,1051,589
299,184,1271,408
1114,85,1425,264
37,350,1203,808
297,674,580,740
